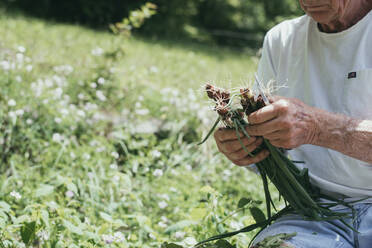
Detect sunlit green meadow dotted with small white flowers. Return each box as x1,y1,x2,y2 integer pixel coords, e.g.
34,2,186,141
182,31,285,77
0,9,274,248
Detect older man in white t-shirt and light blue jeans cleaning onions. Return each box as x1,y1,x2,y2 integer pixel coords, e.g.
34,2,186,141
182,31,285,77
215,0,372,248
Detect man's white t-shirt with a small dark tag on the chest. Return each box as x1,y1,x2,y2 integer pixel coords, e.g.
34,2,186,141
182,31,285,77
258,11,372,197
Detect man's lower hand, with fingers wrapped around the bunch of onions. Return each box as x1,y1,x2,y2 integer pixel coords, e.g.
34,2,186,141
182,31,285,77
214,128,270,166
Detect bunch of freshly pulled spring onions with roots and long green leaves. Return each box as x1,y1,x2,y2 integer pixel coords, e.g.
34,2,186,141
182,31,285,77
197,84,355,246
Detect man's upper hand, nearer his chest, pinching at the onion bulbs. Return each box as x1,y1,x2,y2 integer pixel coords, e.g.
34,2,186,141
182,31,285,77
246,96,316,149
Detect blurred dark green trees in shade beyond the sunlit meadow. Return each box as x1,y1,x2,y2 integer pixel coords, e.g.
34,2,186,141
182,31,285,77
3,0,302,48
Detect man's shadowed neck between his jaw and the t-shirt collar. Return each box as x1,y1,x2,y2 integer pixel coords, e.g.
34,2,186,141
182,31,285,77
319,0,372,33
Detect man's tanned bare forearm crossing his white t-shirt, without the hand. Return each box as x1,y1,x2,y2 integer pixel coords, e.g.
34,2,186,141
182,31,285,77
310,108,372,164
